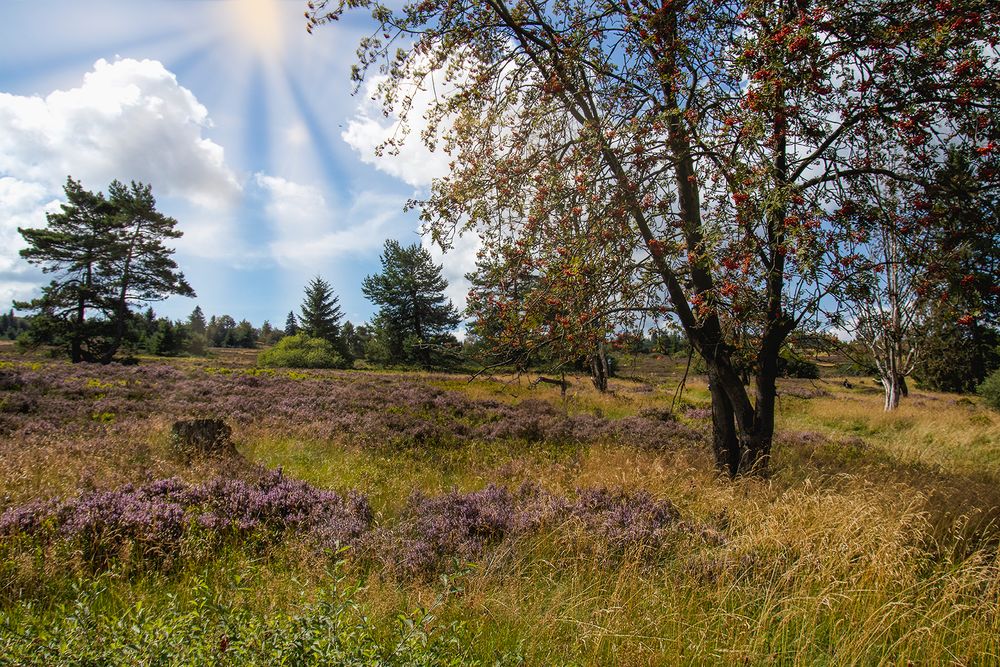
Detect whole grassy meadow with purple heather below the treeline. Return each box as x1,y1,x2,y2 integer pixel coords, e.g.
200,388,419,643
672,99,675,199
0,347,1000,665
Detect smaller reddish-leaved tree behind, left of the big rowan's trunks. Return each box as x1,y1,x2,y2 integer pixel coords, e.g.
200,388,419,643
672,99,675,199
467,206,657,392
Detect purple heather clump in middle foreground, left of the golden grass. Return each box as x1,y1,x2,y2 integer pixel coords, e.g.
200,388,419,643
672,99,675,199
372,484,684,576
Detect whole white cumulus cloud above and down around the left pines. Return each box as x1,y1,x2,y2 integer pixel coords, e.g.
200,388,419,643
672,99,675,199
0,59,248,302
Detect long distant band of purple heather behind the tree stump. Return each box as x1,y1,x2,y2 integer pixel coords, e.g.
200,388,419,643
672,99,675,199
0,354,702,450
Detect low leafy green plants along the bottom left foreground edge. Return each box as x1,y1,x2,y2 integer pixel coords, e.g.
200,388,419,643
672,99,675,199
0,575,488,667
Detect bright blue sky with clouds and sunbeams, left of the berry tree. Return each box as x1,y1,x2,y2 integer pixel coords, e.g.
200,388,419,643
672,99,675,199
0,0,475,326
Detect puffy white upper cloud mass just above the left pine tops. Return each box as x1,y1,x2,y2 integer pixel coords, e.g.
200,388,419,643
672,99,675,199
0,59,240,207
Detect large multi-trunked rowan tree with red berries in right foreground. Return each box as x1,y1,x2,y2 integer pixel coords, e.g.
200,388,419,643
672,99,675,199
309,0,1000,475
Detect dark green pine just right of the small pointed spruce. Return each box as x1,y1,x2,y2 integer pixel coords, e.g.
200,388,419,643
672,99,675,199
361,240,462,367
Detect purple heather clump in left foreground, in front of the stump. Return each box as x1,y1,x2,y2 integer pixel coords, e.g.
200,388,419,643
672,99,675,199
0,471,372,563
